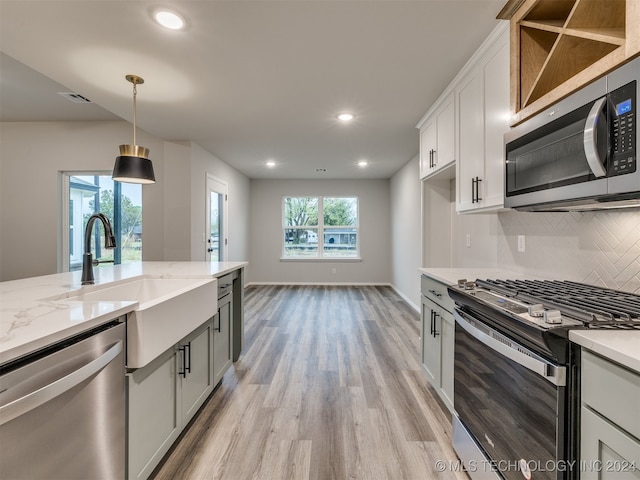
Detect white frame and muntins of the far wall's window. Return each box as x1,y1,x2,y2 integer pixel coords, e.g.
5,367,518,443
280,194,362,262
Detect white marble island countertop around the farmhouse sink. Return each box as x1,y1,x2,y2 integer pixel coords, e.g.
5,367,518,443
0,262,248,364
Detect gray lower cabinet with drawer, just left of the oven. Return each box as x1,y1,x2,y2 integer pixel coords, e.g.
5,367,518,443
420,275,455,412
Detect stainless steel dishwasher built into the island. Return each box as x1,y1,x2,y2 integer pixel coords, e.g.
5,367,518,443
0,321,125,480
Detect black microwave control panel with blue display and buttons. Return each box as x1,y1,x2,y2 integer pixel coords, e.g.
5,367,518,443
609,81,638,176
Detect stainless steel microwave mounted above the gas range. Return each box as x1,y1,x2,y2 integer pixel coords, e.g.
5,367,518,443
504,58,640,211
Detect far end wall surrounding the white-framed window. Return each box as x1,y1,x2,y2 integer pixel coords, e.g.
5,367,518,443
249,179,391,284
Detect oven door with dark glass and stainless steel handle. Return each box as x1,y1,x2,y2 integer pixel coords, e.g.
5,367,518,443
454,309,568,480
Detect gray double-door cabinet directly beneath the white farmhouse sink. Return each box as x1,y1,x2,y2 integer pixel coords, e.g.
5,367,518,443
127,319,214,480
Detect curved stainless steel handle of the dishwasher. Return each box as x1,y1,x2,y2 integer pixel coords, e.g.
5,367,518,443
0,340,122,425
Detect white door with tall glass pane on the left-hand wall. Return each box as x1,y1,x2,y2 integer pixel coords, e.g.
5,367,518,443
205,174,228,262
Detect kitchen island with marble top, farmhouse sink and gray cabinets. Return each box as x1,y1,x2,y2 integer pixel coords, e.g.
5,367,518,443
0,262,247,479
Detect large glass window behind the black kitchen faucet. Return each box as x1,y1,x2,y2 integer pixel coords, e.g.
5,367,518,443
61,172,142,271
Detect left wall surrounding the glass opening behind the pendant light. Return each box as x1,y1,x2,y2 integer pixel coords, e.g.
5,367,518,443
0,121,165,281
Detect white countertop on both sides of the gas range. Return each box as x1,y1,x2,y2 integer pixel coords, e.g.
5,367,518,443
420,267,640,372
